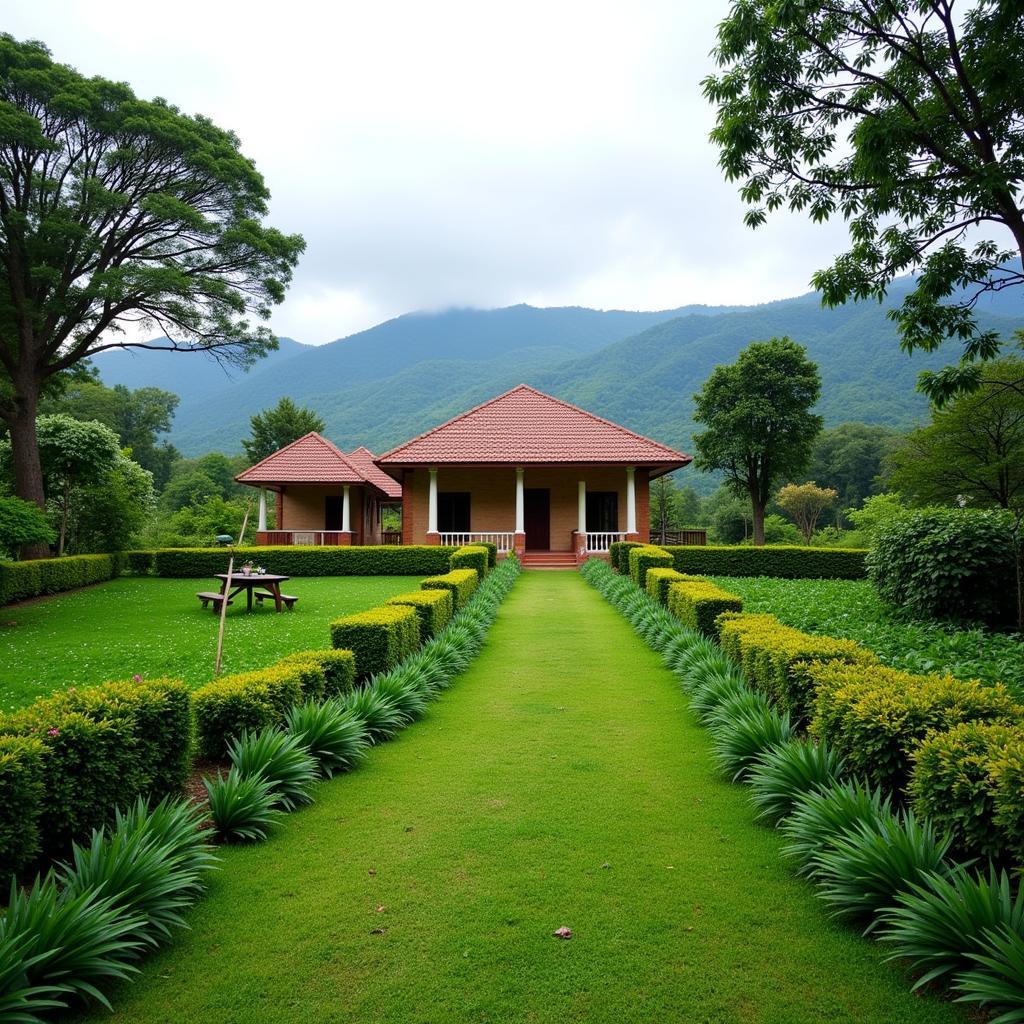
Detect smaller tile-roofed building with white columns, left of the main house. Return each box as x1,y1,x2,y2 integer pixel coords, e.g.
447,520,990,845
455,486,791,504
236,431,401,545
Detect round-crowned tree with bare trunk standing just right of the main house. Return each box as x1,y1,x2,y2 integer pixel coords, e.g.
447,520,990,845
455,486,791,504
693,338,822,545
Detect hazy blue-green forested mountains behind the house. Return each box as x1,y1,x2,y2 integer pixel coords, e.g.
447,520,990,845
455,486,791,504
96,284,1024,468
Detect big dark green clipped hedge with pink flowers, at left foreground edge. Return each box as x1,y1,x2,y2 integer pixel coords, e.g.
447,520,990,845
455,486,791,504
0,679,193,871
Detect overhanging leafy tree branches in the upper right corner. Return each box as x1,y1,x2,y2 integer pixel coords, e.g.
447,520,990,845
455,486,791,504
703,0,1024,400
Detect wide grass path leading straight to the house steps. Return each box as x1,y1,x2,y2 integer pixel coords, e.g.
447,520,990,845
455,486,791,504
83,572,966,1024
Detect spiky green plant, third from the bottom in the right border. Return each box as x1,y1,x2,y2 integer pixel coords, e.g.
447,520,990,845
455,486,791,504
811,811,952,933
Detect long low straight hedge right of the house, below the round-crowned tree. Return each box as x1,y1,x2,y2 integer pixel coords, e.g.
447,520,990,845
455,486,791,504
664,545,867,580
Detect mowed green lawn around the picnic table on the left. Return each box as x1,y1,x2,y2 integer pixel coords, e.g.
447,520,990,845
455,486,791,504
0,577,420,711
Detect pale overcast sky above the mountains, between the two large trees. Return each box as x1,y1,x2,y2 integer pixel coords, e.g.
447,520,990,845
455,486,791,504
9,0,844,344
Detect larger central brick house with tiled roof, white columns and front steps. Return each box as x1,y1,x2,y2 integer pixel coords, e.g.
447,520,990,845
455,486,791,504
376,384,691,559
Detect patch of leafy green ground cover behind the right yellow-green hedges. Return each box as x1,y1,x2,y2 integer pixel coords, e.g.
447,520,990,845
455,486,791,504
715,577,1024,696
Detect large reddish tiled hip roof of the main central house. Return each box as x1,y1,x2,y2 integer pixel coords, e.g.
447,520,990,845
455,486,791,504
377,384,691,472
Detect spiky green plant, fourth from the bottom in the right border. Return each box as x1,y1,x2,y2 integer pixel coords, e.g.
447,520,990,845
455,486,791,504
779,779,892,874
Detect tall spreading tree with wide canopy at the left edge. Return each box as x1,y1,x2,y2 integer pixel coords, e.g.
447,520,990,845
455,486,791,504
0,35,303,553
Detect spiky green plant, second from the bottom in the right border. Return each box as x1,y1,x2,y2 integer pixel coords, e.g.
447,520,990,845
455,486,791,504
879,865,1024,988
